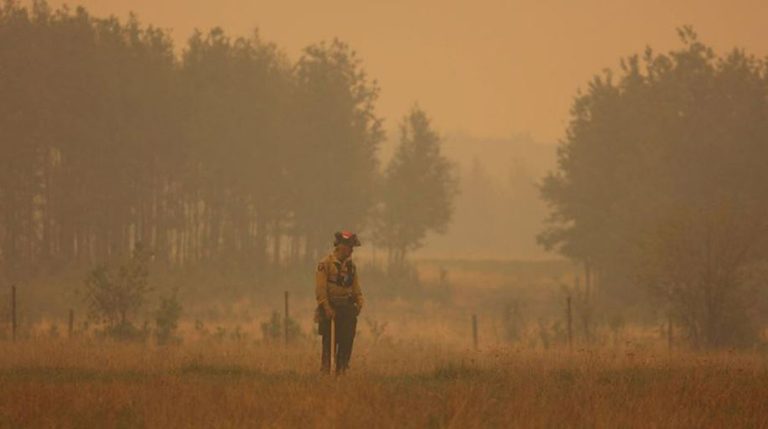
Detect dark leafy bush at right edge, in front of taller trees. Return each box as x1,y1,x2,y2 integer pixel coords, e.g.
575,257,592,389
639,202,768,348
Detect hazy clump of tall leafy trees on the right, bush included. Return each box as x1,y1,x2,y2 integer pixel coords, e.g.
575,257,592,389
539,28,768,347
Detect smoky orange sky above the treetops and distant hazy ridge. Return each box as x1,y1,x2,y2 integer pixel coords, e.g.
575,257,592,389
50,0,768,141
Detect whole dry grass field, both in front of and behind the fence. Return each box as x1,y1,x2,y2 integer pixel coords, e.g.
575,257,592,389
0,261,768,428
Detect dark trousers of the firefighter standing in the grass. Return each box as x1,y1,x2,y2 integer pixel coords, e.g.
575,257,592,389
319,304,357,373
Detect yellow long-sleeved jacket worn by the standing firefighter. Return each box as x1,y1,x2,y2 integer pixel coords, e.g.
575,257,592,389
315,252,363,310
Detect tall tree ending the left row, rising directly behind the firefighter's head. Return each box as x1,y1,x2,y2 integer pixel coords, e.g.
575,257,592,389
289,40,384,254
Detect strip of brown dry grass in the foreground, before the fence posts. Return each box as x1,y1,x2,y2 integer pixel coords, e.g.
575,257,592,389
0,340,768,428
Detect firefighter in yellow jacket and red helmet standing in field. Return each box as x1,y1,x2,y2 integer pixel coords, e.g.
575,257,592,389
315,231,363,373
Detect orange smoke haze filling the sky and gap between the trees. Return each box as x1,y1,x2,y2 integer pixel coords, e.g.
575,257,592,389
37,0,768,258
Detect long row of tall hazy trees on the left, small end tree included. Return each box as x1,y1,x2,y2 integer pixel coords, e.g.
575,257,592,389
0,0,457,277
